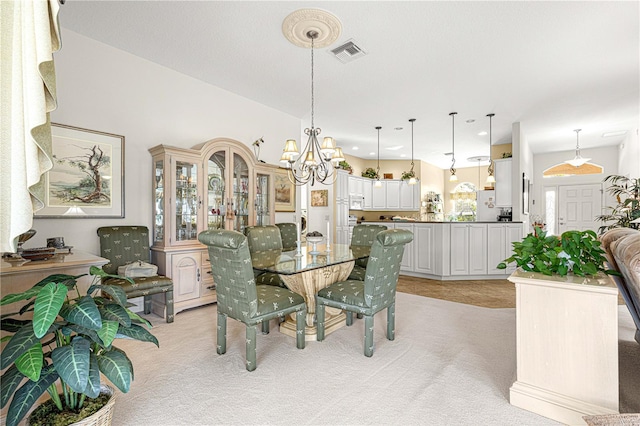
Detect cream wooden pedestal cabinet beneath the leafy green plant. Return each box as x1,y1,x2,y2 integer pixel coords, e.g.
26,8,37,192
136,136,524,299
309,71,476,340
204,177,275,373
509,269,619,424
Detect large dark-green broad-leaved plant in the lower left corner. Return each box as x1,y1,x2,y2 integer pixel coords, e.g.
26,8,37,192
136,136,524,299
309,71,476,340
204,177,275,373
0,266,159,426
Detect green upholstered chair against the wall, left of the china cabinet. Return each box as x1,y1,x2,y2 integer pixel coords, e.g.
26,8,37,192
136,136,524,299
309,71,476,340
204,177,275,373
98,226,173,322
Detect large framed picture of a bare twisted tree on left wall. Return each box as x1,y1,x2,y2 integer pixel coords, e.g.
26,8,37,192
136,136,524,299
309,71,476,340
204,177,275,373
34,123,124,219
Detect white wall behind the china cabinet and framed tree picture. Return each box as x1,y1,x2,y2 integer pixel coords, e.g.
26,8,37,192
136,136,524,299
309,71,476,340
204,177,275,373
35,29,301,254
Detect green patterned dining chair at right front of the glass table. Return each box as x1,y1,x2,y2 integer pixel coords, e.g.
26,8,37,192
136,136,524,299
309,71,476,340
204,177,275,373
316,229,413,356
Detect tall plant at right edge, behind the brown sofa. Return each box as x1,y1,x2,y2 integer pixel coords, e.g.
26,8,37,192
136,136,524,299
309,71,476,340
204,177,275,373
596,175,640,234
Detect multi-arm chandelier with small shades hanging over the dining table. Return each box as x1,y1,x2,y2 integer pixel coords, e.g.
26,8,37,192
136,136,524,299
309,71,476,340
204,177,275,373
280,30,344,185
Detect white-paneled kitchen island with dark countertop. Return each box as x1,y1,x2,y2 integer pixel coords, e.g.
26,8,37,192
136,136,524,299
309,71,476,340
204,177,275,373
362,220,524,280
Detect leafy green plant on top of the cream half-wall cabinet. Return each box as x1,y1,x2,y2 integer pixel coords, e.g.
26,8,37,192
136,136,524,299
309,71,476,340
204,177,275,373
497,228,616,277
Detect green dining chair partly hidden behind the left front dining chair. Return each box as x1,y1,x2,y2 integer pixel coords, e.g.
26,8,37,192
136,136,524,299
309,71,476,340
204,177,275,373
244,225,287,288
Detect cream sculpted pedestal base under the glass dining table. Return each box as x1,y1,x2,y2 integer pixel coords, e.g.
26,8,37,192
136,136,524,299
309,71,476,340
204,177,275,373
280,262,355,342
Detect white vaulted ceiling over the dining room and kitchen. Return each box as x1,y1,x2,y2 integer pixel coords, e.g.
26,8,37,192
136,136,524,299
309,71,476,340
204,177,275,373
60,0,640,168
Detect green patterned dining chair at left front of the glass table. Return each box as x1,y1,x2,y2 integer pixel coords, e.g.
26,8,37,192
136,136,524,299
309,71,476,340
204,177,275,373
198,230,307,371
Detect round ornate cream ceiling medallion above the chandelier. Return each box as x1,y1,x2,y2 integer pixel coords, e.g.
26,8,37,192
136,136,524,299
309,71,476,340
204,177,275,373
282,9,342,49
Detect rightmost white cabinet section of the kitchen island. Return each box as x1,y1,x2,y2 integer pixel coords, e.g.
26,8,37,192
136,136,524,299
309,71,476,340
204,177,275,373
487,223,523,275
